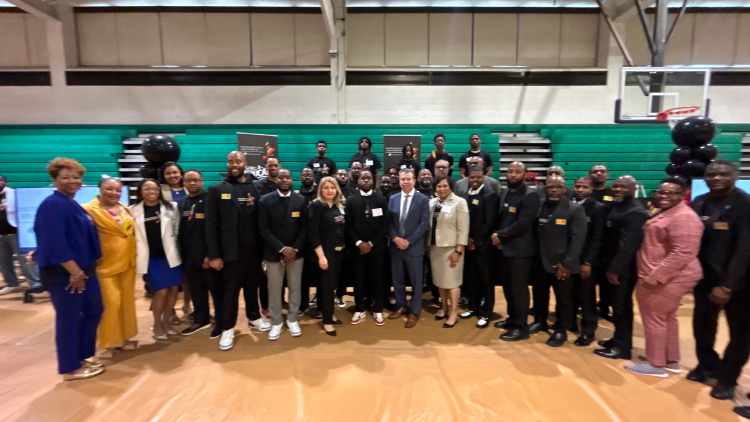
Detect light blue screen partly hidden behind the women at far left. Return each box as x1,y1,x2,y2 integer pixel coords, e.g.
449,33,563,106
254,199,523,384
15,186,128,251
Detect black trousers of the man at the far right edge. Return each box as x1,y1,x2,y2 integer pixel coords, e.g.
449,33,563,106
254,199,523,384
693,280,750,386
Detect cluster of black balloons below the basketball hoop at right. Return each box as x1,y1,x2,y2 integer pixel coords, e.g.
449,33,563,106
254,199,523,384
665,116,719,180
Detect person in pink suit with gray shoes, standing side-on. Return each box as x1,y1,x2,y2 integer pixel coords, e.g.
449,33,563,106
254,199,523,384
627,178,703,378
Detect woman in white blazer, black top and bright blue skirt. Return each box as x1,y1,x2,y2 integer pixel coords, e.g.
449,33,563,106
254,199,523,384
131,179,183,340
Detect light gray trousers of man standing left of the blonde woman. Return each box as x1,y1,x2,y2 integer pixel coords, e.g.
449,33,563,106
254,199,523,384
263,258,305,325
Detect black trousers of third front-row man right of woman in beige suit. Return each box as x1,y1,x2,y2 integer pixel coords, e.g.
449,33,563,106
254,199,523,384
533,270,574,333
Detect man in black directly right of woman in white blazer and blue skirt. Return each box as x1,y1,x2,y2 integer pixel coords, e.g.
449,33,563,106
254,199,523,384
177,170,223,338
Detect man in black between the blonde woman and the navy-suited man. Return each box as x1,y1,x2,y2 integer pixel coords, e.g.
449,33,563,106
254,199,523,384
346,170,388,325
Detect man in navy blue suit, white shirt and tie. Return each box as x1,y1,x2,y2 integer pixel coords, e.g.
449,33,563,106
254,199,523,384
388,169,430,328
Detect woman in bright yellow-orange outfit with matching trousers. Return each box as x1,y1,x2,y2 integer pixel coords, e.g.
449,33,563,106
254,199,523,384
83,178,138,357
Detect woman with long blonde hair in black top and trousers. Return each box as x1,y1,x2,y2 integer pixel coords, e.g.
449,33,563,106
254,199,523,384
308,177,346,336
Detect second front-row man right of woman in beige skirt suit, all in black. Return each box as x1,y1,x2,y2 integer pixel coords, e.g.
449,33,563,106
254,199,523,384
491,161,539,341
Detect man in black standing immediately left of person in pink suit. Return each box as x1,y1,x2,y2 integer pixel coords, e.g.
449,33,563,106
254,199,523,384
594,176,648,359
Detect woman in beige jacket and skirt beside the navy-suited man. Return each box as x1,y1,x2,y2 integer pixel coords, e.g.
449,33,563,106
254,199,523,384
430,176,469,328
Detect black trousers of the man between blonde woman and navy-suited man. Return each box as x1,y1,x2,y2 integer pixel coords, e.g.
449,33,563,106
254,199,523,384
354,248,385,312
